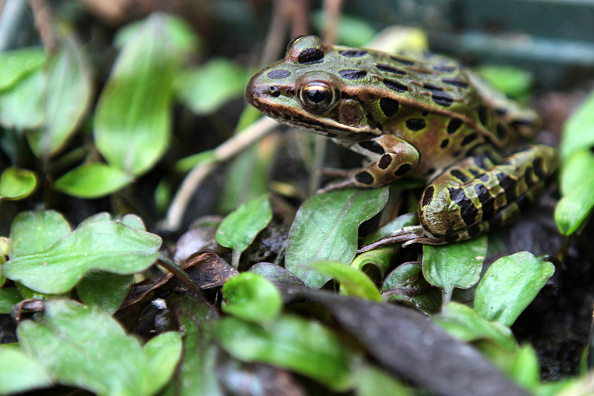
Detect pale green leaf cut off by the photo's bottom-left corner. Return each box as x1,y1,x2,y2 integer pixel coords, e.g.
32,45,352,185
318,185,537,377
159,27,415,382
0,345,52,395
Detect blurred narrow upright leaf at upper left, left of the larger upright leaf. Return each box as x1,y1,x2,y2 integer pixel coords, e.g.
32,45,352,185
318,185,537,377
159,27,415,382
27,37,92,157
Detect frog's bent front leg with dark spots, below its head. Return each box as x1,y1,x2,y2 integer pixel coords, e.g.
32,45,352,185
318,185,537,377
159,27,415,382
320,134,420,192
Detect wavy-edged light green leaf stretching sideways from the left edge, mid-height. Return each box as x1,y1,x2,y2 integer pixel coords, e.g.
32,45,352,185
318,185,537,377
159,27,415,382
2,221,161,294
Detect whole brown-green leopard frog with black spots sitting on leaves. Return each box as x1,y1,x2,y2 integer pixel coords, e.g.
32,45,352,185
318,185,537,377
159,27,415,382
246,36,557,244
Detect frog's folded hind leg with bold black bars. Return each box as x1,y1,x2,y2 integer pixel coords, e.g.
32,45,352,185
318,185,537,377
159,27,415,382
419,145,557,242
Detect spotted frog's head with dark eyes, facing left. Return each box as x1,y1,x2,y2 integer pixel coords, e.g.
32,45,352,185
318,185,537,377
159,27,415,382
246,36,381,141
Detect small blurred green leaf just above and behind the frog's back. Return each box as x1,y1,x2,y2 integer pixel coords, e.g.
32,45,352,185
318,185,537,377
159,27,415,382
478,65,534,98
